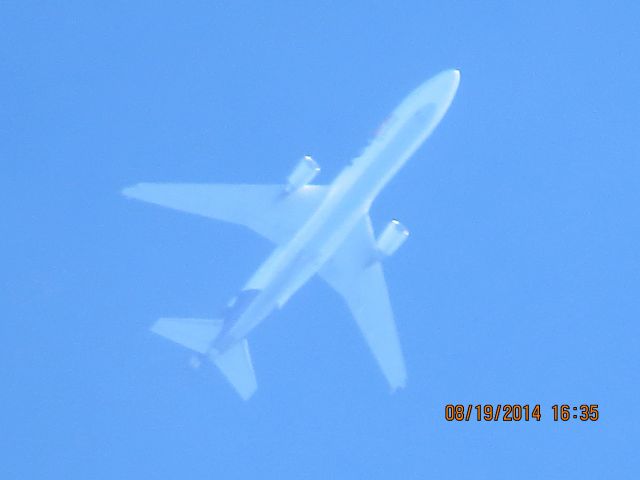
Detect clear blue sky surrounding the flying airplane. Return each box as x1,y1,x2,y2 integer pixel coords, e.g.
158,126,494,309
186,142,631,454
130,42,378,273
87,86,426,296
0,1,640,479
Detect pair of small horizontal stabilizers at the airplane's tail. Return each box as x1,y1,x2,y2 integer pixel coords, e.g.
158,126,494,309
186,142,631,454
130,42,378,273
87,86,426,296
151,318,258,400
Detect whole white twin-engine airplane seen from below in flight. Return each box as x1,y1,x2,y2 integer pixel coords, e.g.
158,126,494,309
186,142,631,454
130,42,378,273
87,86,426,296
123,70,460,400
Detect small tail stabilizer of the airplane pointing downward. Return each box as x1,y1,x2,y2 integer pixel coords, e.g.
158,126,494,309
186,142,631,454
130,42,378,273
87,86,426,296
210,338,258,400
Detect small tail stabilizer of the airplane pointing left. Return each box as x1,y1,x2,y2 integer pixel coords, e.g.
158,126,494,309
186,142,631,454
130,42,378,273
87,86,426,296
151,318,222,354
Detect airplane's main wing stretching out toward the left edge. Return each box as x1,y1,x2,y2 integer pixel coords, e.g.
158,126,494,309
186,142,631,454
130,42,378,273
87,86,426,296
122,183,329,244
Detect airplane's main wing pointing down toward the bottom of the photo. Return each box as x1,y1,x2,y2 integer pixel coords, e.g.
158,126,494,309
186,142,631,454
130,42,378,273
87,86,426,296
319,215,407,390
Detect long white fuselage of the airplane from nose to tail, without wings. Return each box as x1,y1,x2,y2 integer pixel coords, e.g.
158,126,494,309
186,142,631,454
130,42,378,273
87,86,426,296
212,70,459,351
